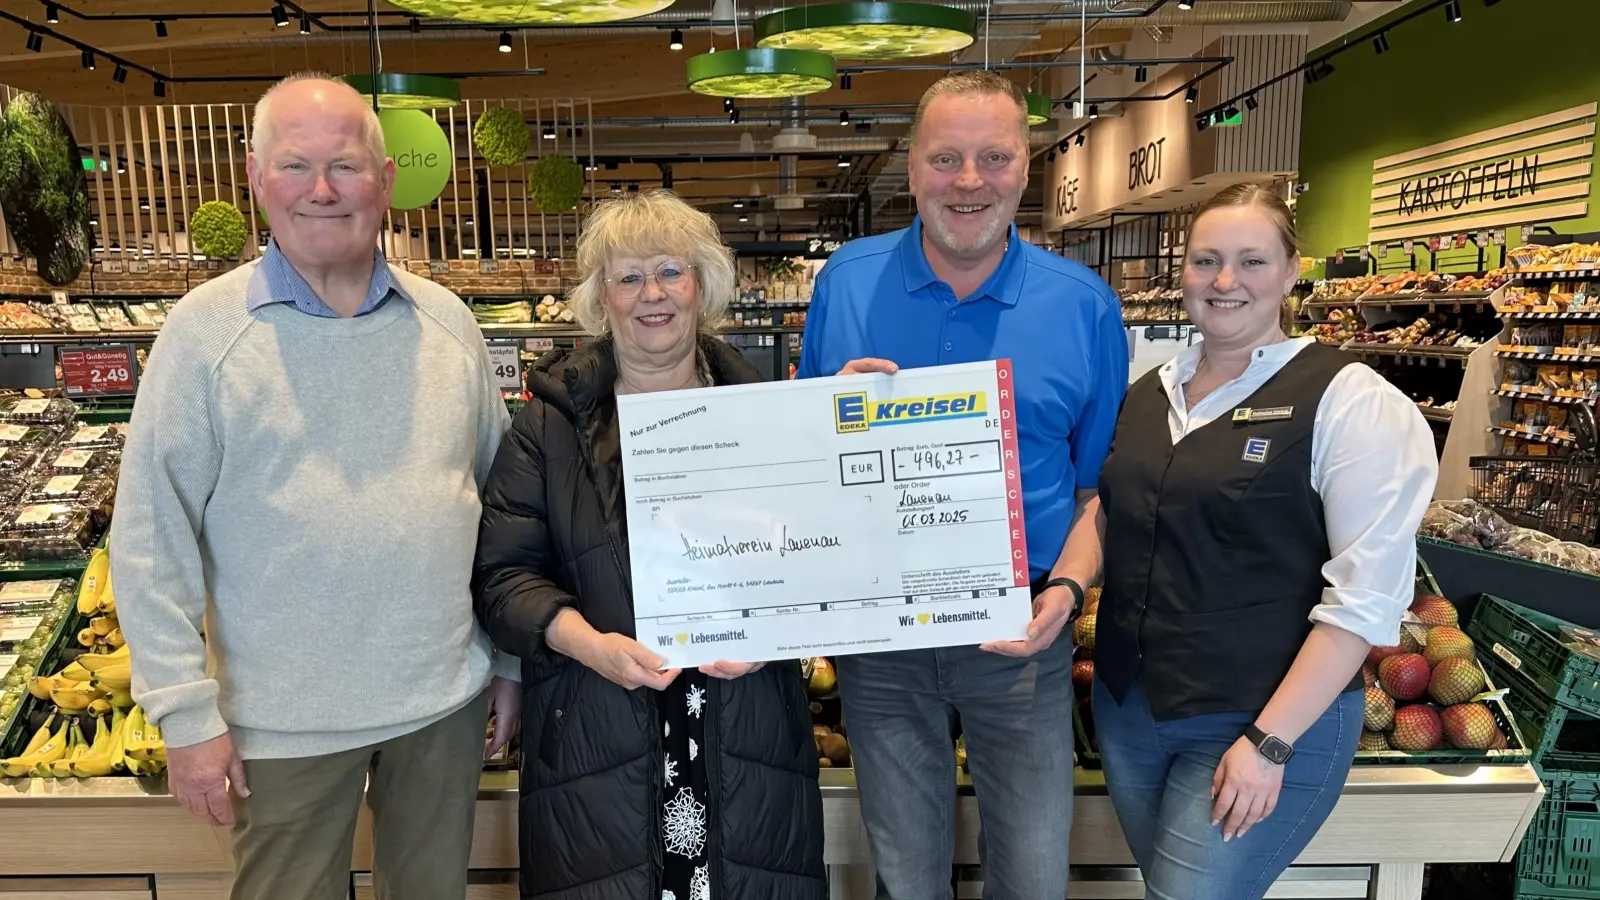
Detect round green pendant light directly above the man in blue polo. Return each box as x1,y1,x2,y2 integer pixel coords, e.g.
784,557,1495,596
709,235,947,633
755,0,978,59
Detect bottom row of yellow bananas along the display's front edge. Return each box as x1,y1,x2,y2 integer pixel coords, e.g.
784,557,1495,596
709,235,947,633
0,706,166,778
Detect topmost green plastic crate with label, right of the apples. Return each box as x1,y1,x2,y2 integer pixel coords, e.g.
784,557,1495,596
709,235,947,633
1467,594,1600,716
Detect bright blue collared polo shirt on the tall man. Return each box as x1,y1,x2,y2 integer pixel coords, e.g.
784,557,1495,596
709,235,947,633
797,216,1128,580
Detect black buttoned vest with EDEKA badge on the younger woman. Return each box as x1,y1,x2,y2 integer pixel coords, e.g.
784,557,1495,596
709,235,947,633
1094,344,1362,721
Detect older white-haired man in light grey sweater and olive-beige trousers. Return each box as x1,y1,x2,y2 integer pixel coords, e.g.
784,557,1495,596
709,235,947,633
112,75,518,900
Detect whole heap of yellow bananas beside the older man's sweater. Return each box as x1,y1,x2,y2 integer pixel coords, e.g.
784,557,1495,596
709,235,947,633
0,549,166,778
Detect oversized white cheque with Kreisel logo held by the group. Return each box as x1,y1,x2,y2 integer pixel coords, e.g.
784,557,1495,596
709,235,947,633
618,360,1032,666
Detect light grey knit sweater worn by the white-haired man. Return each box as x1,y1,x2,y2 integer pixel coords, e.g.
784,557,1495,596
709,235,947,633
110,264,517,759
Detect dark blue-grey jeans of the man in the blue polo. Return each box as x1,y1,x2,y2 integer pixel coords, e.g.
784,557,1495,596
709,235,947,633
835,634,1074,900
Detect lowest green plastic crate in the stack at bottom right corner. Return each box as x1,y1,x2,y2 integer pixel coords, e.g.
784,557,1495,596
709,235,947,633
1517,768,1600,900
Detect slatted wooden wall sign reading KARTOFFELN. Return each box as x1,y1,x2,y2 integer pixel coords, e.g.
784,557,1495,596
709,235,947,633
1366,102,1597,242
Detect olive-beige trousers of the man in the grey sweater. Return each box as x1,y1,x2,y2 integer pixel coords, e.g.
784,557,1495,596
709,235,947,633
230,692,488,900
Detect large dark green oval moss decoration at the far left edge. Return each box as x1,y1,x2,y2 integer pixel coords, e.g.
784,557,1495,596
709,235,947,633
0,94,90,285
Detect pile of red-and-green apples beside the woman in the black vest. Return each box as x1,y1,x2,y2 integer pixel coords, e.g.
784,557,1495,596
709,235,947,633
1360,593,1510,753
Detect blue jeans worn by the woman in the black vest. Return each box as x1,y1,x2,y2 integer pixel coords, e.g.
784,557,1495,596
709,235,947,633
1093,679,1365,900
